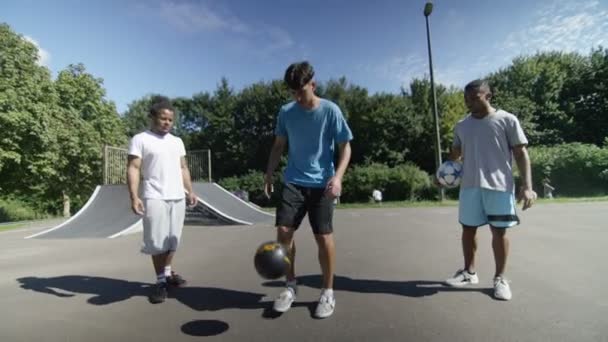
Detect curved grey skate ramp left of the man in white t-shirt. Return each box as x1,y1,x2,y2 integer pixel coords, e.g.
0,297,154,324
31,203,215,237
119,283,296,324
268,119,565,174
26,185,142,239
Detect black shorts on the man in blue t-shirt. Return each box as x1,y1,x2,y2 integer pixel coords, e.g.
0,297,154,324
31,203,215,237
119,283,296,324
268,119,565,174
276,183,335,234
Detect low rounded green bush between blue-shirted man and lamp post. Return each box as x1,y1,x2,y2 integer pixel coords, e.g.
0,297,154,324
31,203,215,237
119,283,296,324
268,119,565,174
340,163,432,202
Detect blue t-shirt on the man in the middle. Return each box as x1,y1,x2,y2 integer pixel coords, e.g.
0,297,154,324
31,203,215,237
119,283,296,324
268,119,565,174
275,99,353,188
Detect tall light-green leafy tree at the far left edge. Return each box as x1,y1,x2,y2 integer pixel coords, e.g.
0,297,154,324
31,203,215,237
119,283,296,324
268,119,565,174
0,24,59,207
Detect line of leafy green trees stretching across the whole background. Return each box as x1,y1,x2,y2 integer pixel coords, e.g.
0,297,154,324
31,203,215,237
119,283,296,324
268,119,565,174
0,24,608,218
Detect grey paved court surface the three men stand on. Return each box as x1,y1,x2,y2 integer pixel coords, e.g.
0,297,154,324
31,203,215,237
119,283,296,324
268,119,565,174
0,202,608,342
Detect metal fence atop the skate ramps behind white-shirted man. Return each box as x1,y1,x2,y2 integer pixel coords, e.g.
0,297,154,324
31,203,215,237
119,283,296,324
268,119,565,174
103,146,211,185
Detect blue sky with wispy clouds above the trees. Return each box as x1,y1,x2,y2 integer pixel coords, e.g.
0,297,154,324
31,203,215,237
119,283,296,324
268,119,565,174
0,0,608,112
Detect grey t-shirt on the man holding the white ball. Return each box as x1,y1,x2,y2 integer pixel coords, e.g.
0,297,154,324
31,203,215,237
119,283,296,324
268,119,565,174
453,110,528,192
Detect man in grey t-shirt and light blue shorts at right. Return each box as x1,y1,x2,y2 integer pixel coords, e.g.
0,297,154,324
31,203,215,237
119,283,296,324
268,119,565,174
446,80,536,300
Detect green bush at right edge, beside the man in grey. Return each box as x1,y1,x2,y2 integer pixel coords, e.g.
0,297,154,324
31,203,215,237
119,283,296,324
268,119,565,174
530,143,608,196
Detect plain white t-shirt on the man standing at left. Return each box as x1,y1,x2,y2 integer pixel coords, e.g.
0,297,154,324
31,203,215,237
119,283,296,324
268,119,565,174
129,131,186,200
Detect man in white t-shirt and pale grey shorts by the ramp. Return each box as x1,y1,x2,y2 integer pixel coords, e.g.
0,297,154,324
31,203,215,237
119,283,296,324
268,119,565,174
127,97,197,303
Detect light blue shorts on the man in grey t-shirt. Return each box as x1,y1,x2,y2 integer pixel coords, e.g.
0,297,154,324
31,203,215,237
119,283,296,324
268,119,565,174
458,188,519,228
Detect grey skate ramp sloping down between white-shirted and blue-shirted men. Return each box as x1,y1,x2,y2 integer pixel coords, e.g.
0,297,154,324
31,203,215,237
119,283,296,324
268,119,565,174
192,183,274,225
